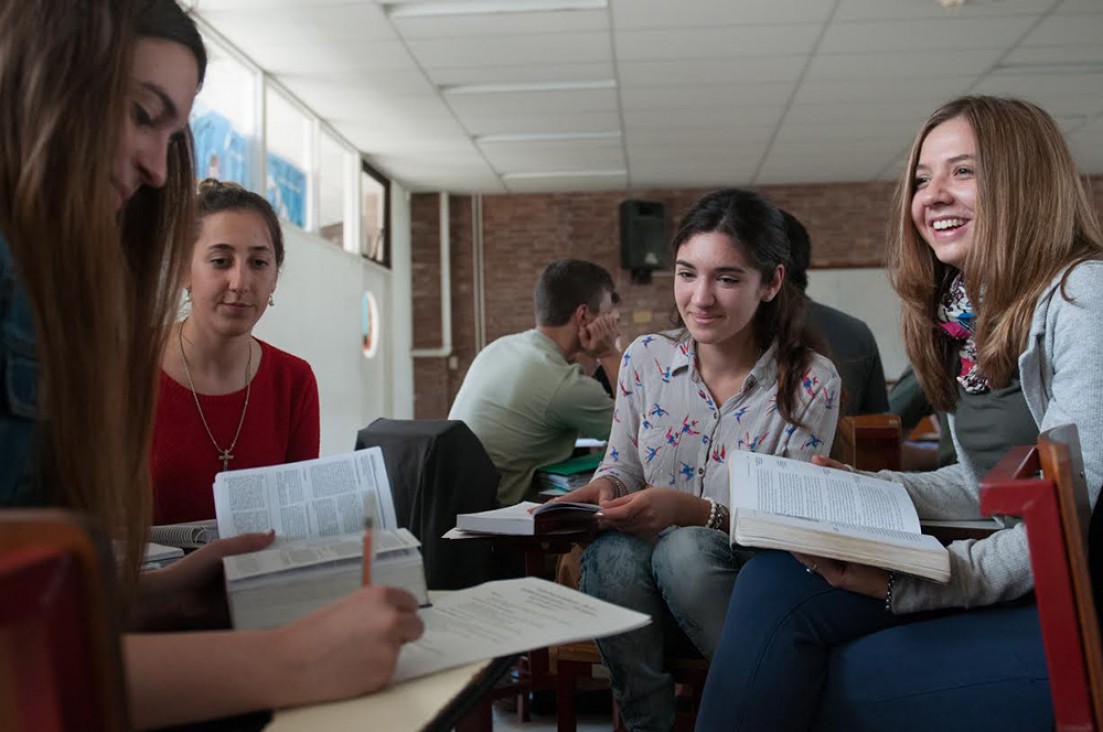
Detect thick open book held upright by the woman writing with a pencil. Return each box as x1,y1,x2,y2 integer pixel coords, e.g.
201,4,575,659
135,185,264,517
214,448,429,628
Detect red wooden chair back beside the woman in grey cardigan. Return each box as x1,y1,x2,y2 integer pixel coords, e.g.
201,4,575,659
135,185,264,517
981,426,1103,730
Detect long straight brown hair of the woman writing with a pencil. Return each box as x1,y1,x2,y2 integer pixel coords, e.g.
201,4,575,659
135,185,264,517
0,0,202,589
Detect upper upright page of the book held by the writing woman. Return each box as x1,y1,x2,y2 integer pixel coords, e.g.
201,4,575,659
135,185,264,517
214,448,398,541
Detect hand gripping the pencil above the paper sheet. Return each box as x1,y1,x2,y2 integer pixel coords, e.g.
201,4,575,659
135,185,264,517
272,585,425,707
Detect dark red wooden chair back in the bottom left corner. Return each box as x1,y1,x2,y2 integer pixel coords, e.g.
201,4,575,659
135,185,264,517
0,510,129,732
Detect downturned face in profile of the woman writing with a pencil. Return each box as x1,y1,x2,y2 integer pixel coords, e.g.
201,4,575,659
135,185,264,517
111,39,199,207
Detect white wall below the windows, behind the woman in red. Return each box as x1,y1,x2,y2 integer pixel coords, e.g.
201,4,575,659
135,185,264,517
255,186,414,455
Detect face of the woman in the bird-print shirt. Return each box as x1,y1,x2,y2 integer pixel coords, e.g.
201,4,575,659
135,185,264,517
674,232,784,347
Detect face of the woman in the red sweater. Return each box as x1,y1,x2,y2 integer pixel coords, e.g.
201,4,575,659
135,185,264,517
185,211,278,337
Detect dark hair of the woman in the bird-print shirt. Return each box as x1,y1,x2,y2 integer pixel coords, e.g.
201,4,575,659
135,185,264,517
671,189,812,424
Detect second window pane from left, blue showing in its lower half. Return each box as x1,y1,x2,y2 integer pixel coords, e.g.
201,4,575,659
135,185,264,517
265,86,314,228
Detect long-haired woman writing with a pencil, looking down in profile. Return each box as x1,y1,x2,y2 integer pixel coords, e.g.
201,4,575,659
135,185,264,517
0,0,421,726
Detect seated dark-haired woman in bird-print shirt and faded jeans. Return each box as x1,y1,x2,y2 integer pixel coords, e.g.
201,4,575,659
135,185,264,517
563,190,840,730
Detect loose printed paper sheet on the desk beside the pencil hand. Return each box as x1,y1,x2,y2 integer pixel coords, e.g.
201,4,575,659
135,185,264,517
395,577,651,682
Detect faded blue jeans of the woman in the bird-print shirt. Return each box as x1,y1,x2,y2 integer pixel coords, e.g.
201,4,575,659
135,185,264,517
579,526,742,732
